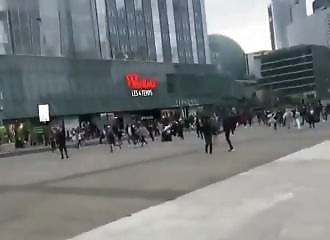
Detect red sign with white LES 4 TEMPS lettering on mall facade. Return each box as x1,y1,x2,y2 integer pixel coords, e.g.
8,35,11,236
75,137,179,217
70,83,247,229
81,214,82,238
125,73,157,97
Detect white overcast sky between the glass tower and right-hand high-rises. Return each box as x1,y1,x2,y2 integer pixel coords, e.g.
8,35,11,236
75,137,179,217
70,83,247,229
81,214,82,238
205,0,313,53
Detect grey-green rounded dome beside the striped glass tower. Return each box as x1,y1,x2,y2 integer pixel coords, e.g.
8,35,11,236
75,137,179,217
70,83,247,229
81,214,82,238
209,34,246,80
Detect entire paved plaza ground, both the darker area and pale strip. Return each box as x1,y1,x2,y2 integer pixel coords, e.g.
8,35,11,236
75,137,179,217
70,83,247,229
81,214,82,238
0,123,330,240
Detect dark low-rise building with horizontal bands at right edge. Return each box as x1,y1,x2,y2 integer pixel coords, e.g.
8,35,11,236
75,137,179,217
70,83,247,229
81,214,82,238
258,45,330,100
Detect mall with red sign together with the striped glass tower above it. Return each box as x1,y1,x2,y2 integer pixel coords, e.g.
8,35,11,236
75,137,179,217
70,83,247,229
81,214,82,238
0,0,229,121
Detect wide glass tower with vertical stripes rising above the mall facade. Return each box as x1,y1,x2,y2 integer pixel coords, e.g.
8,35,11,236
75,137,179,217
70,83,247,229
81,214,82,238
0,0,210,64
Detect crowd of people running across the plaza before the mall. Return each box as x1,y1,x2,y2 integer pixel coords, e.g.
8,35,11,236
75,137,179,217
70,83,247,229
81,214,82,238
51,101,329,159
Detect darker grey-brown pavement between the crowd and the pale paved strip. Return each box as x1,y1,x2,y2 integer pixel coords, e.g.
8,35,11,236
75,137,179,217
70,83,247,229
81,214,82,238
0,124,330,240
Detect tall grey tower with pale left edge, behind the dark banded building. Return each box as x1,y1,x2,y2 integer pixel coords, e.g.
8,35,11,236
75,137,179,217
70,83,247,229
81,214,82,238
268,0,307,49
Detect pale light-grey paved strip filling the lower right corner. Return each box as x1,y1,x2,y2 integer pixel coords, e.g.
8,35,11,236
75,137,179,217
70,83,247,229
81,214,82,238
72,141,330,240
